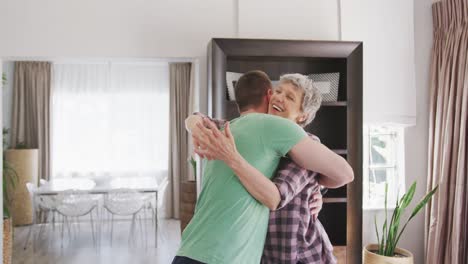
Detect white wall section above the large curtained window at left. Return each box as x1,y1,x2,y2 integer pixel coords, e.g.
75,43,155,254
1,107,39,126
0,0,234,57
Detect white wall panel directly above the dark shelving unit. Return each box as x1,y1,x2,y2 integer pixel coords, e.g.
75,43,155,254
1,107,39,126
239,0,340,40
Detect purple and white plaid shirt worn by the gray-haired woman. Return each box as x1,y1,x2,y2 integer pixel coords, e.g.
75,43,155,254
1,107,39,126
196,113,336,264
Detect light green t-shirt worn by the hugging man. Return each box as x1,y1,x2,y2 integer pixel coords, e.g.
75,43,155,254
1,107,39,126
177,113,306,264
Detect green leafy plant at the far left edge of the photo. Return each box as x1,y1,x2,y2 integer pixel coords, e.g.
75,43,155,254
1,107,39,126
2,128,18,218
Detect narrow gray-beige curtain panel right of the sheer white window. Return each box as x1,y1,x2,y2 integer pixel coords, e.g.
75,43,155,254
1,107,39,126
167,63,192,219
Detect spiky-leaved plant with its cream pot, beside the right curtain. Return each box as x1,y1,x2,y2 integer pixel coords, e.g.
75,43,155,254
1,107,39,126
363,182,438,264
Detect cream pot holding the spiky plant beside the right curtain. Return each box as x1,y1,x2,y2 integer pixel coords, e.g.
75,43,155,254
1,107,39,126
362,244,414,264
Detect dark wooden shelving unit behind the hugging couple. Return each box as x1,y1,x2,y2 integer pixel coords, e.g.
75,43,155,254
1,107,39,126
208,39,362,264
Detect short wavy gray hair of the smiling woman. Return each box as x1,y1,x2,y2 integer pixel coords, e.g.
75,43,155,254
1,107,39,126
279,73,322,127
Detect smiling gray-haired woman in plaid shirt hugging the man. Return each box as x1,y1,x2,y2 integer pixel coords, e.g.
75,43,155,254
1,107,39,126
194,74,336,264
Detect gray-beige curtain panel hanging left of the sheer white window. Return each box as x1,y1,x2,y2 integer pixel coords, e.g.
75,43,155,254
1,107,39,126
11,61,52,180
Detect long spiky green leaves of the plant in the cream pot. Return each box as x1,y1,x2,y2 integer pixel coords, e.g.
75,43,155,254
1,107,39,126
374,182,439,257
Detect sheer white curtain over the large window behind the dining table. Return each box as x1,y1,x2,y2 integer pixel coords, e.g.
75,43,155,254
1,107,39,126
51,62,169,182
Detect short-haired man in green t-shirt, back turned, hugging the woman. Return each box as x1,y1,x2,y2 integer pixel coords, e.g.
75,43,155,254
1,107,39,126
173,71,353,263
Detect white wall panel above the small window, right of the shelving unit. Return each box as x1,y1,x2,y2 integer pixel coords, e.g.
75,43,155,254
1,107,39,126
341,0,416,125
